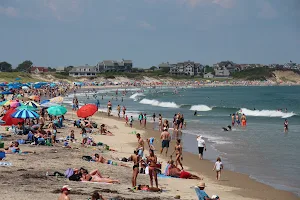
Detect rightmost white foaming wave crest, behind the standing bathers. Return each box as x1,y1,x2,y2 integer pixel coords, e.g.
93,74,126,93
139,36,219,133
240,108,295,118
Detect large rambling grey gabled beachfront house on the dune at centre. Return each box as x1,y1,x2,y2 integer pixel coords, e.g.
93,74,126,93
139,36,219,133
158,61,203,76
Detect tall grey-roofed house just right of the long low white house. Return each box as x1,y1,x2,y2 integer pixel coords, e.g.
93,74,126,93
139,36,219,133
96,59,132,72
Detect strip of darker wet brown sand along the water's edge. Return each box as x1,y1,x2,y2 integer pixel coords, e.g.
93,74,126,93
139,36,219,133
95,112,300,200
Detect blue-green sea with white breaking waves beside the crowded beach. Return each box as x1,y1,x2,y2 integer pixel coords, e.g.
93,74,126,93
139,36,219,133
66,86,300,196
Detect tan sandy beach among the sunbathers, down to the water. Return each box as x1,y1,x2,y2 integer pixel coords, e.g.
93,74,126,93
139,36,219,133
0,104,299,200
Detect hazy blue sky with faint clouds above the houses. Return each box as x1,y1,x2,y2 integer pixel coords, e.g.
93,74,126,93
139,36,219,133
0,0,300,68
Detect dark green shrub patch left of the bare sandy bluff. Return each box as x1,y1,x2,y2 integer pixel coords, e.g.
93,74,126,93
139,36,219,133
232,67,274,81
